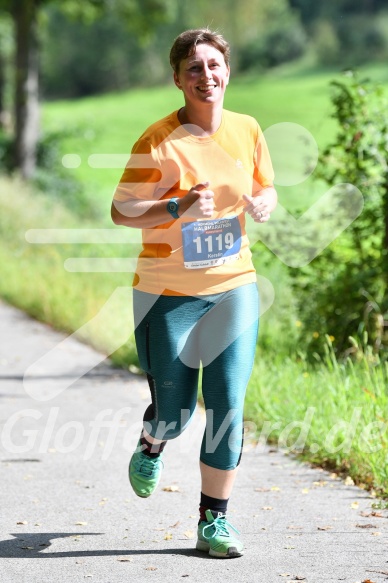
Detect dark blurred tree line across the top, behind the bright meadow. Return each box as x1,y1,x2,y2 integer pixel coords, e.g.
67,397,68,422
0,0,388,178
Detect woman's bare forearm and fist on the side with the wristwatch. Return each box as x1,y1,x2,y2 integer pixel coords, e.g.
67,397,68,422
111,182,214,229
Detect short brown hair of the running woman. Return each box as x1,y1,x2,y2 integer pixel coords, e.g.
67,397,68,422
170,28,230,73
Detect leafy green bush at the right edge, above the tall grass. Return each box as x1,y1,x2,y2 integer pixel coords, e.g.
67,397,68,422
291,72,388,358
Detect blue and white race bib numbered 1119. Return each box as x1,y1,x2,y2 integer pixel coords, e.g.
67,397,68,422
182,217,241,269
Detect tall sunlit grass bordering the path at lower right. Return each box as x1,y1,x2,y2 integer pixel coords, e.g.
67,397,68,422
245,338,388,497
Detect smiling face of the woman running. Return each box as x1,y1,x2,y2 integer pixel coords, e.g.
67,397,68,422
174,43,230,105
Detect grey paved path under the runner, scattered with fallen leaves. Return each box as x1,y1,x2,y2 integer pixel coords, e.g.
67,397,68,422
0,304,388,583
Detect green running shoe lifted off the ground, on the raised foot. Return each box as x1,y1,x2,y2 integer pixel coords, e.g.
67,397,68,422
128,441,164,498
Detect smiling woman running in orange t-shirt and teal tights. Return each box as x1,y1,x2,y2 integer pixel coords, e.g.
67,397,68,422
112,29,277,558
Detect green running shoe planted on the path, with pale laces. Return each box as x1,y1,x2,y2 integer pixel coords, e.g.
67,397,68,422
196,510,244,559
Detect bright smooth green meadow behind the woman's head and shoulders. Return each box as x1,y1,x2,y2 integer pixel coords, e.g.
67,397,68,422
43,64,388,219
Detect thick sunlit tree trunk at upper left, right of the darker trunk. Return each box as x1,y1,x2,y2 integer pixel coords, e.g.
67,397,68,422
13,0,39,179
